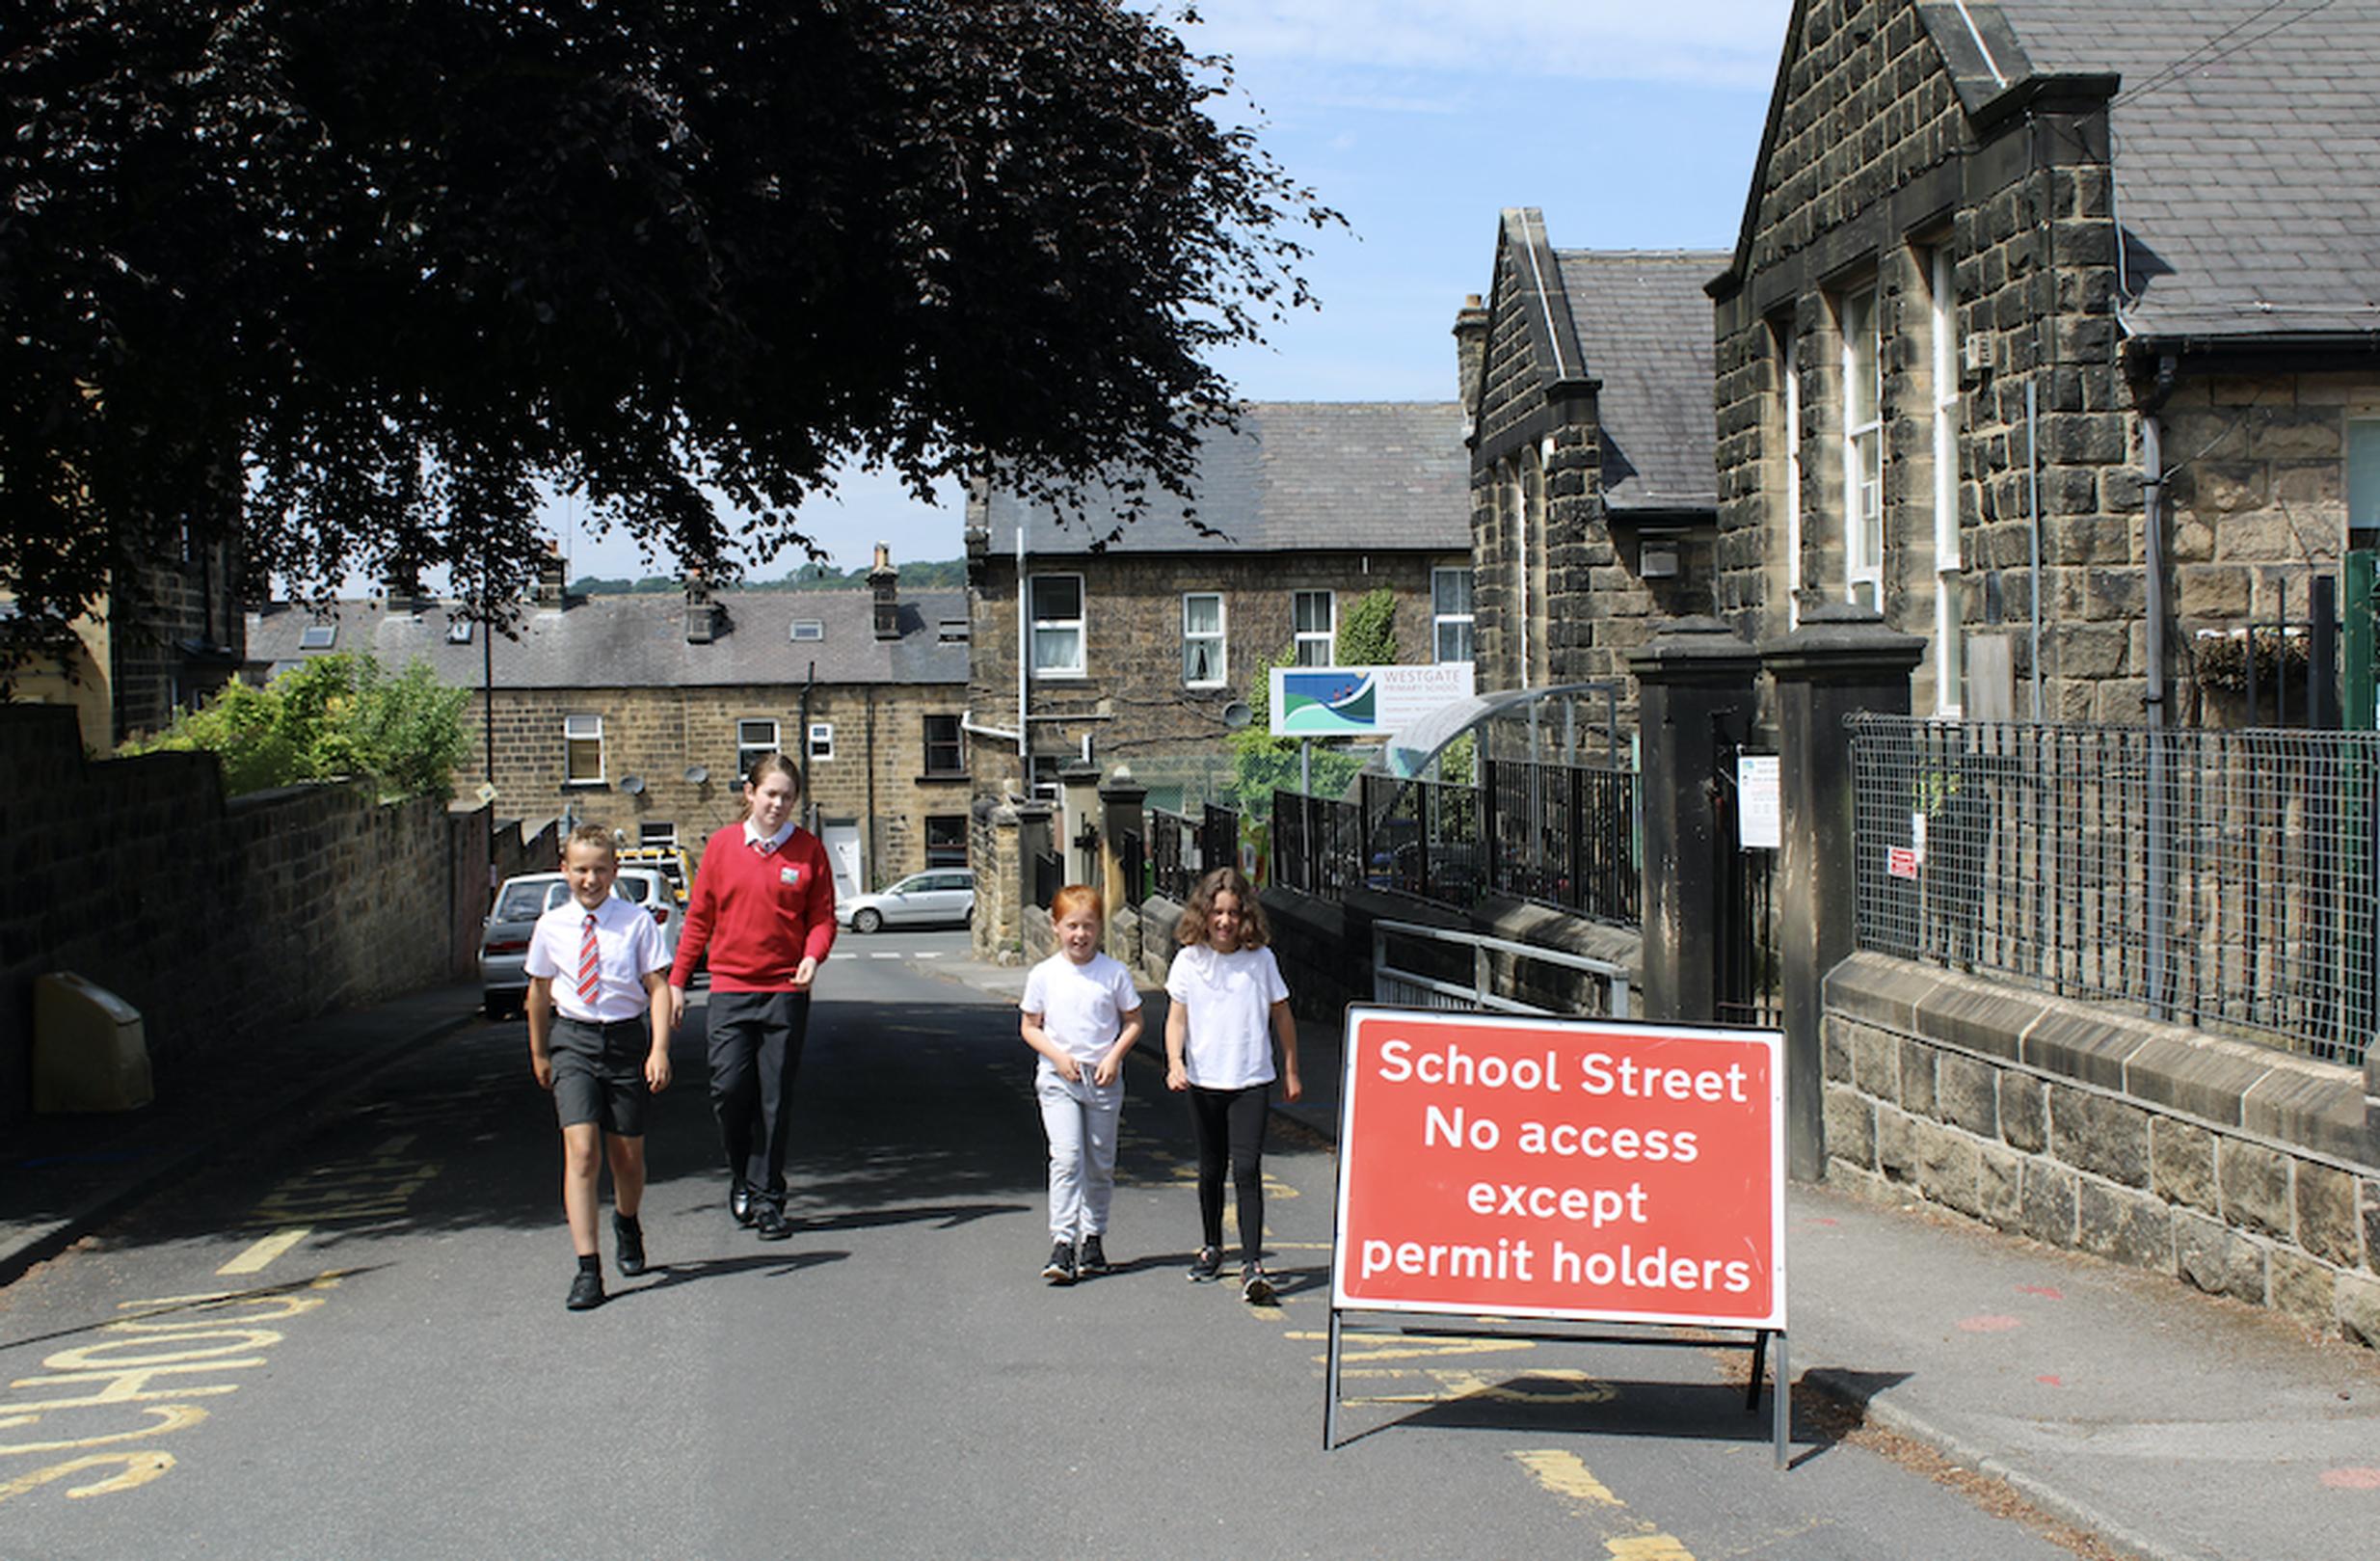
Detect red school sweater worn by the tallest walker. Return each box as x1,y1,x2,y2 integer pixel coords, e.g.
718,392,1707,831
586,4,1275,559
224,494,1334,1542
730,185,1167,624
669,823,836,992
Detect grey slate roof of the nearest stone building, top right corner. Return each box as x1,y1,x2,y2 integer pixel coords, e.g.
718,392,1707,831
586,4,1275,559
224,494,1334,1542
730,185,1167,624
1968,0,2380,337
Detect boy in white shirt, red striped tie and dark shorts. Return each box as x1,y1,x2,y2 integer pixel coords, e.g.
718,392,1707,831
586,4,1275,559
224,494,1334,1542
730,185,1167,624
526,823,669,1311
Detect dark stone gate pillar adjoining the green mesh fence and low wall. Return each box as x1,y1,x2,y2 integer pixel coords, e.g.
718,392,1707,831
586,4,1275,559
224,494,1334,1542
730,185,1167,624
1761,602,1925,1180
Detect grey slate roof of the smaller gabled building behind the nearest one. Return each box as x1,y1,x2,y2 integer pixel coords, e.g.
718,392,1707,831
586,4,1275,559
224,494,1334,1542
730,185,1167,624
1554,250,1727,509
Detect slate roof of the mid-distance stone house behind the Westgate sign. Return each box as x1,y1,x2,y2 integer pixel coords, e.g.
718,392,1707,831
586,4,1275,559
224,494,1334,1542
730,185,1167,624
983,402,1465,557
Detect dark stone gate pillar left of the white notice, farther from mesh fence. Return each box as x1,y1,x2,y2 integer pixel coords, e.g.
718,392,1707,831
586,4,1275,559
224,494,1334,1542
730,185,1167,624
1628,616,1761,1021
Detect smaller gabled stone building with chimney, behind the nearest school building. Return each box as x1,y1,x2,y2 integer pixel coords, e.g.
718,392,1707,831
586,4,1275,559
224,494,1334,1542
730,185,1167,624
1455,207,1727,705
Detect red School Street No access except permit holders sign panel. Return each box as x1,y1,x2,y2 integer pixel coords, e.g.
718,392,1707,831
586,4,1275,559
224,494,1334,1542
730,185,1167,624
1330,1007,1785,1331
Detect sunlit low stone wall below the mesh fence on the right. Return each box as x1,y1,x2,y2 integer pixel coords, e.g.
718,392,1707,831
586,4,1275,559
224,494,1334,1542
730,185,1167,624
1826,955,2380,1349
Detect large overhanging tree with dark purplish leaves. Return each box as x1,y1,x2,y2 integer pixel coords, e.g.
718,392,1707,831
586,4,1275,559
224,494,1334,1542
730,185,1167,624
0,0,1338,621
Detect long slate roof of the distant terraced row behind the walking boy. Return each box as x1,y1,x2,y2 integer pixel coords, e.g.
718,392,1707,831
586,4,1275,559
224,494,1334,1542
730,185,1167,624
248,590,966,687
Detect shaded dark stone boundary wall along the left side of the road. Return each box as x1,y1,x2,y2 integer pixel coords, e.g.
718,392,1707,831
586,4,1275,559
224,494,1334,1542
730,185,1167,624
0,705,486,1123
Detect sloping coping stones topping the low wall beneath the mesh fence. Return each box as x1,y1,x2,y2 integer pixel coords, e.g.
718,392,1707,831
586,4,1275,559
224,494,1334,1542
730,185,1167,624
1826,952,2380,1178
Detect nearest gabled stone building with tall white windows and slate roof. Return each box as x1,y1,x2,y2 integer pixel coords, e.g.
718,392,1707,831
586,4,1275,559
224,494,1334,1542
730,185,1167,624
1723,0,2380,726
